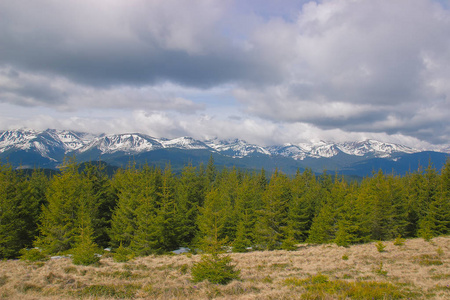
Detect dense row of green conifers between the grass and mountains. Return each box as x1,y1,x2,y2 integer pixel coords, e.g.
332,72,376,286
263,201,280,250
0,158,450,258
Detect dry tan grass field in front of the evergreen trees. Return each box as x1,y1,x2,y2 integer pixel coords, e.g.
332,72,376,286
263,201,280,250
0,236,450,300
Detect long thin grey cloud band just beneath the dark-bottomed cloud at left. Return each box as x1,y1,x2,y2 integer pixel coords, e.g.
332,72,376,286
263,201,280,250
0,68,204,113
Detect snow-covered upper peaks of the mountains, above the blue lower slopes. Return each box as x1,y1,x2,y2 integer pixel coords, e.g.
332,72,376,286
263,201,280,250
0,129,432,160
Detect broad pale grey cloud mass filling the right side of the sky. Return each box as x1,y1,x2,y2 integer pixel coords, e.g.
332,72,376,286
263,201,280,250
235,0,450,143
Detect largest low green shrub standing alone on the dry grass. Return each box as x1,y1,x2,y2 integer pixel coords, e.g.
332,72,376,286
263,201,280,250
191,254,241,284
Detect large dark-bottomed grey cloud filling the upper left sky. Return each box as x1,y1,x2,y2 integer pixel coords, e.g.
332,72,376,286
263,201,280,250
0,0,282,87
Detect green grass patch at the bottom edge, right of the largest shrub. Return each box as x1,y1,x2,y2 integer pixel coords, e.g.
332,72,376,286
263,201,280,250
284,274,409,300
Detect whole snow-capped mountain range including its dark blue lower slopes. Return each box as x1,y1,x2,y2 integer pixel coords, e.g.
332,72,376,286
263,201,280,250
0,129,450,176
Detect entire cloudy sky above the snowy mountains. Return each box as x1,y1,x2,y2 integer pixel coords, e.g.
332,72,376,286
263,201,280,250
0,0,450,148
